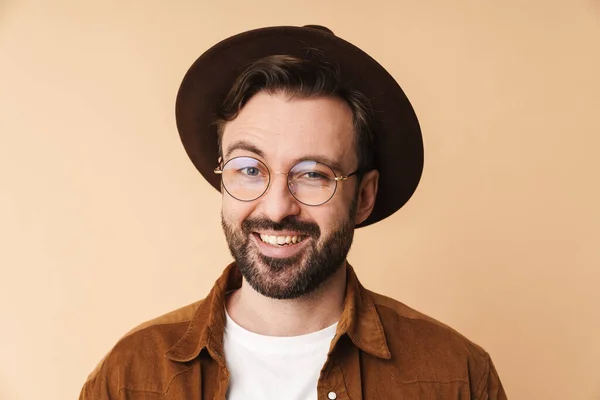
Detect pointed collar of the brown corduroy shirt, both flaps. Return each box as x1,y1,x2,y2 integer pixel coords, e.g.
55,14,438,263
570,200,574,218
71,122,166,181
166,263,391,366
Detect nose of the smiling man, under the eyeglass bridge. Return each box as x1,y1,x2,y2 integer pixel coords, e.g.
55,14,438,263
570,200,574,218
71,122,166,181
259,174,300,222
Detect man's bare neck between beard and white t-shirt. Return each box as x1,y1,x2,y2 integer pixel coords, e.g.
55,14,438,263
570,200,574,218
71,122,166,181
226,264,346,336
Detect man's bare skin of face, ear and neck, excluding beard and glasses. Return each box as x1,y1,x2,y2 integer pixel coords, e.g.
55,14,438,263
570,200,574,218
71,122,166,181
222,93,378,336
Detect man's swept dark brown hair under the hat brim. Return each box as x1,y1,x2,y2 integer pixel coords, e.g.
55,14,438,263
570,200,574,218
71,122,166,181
216,55,375,176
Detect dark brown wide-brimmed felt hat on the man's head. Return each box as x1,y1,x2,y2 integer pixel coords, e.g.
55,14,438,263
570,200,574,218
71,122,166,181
175,25,423,226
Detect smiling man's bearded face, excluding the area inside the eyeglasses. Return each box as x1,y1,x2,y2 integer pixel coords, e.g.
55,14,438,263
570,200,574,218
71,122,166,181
222,93,366,299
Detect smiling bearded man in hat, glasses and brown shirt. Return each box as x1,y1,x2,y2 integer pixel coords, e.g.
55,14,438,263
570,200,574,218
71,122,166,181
81,26,506,400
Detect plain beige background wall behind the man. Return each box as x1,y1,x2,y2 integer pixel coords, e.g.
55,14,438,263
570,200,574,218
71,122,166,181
0,0,600,400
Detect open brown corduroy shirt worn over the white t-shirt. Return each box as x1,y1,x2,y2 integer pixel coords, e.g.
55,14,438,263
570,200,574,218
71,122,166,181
80,264,506,400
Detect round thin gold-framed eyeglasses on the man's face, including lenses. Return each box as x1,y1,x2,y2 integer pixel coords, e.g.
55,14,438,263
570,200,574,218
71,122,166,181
214,157,358,206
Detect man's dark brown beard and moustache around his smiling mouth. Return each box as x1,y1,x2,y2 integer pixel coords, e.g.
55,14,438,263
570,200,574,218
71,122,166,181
221,201,356,300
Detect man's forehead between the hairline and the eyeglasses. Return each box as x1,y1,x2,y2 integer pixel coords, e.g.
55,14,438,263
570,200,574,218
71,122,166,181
222,93,356,168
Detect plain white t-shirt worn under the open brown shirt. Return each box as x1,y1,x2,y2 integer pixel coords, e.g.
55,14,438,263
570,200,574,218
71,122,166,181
224,314,337,400
